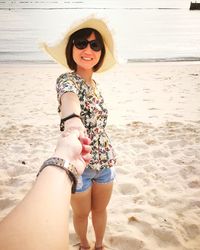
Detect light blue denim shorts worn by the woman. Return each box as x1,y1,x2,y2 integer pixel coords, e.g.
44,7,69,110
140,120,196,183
76,167,116,192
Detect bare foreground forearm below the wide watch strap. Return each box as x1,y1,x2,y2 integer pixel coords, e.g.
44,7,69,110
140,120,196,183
0,166,71,250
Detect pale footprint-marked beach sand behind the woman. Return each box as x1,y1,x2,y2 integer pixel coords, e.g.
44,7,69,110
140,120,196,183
0,62,200,250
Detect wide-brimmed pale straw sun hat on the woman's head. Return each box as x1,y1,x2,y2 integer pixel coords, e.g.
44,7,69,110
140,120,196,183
41,17,116,72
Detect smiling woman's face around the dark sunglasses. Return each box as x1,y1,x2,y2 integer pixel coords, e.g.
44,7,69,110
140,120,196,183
72,33,101,70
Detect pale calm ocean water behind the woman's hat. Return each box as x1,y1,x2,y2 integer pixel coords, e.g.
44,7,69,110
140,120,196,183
0,0,200,62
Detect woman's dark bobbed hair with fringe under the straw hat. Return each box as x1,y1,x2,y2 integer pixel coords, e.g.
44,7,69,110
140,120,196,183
65,28,105,72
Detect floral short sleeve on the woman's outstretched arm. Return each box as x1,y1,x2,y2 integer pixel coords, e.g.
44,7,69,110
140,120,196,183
56,74,78,105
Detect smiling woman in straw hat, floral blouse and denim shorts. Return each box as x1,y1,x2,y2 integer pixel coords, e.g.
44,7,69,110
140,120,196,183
44,18,116,250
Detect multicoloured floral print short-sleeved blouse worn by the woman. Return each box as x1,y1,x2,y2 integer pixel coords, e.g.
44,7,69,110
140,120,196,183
56,72,116,170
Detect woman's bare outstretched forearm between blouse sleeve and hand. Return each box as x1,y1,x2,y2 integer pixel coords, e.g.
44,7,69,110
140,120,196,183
61,93,85,131
